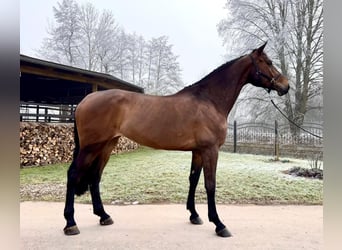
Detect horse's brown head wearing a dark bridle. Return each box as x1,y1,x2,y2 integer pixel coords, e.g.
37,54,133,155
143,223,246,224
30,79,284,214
249,42,290,96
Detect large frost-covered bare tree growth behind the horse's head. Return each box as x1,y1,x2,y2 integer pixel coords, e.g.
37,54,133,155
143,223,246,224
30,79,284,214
218,0,323,134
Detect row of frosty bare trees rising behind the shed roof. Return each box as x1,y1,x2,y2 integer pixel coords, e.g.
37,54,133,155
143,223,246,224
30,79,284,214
39,0,183,94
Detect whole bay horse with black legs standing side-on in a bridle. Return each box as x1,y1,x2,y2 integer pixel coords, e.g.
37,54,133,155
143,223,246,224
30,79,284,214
64,42,289,237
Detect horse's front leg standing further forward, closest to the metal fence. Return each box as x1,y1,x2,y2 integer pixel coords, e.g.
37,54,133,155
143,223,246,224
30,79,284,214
202,148,231,237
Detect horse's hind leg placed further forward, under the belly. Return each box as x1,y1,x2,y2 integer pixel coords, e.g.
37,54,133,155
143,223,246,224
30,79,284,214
90,138,119,225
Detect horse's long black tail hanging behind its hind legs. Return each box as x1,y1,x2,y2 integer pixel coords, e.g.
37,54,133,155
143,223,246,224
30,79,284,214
68,118,89,195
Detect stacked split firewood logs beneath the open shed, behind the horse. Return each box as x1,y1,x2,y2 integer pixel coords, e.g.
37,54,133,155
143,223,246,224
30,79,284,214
20,122,138,167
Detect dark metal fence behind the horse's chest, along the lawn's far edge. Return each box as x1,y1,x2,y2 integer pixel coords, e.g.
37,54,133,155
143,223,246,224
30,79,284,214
223,121,323,159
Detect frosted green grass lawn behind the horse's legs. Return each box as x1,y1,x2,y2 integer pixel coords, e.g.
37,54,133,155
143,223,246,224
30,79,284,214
20,147,323,204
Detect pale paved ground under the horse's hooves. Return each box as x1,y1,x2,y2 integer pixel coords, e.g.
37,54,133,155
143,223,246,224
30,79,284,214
20,202,323,250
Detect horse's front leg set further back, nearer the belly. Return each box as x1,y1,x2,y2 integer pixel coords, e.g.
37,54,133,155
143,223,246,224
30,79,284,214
186,151,203,225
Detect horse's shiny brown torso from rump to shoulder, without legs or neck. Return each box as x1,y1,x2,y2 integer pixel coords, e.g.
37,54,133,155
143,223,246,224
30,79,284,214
76,90,226,150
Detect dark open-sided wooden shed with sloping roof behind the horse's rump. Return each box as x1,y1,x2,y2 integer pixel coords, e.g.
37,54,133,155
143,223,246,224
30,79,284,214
20,55,144,122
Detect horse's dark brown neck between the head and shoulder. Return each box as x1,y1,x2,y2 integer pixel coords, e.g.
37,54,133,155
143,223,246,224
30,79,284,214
196,58,250,117
